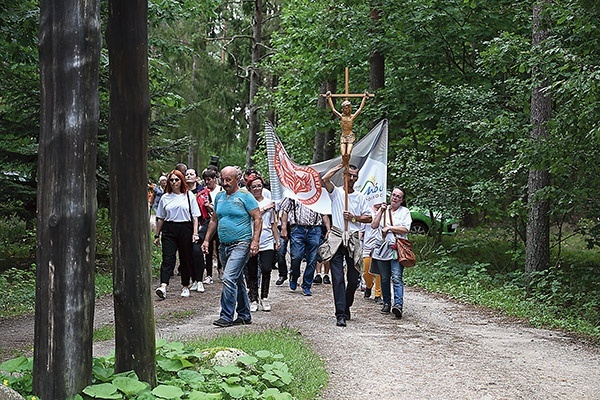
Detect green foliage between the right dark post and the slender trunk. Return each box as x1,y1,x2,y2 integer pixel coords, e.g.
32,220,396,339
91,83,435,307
148,1,250,172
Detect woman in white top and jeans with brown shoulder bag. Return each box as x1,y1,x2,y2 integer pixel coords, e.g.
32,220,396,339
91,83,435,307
371,187,412,318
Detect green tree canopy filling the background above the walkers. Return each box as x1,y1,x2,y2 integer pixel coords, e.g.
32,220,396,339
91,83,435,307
0,0,600,245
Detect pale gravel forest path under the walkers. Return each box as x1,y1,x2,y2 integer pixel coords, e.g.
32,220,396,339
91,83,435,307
0,273,600,400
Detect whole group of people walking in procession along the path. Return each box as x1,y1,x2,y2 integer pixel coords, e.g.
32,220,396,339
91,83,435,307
150,164,411,327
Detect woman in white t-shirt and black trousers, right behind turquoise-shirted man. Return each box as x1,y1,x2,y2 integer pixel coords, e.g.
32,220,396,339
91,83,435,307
246,174,279,312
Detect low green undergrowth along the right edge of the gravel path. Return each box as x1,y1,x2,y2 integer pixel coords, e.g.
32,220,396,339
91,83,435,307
405,230,600,340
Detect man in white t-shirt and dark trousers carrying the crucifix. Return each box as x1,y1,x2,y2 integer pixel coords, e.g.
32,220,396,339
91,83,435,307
323,164,372,326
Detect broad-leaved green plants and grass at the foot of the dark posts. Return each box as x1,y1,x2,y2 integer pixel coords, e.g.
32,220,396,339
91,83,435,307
0,330,325,400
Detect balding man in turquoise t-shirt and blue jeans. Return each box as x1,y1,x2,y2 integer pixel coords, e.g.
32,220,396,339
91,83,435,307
202,167,262,328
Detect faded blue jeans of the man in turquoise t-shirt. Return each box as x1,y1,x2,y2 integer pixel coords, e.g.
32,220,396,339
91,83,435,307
219,240,251,322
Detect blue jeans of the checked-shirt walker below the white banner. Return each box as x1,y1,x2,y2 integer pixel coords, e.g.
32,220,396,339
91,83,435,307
290,225,323,289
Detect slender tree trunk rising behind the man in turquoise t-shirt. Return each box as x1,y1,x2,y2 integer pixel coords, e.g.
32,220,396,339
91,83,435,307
246,0,262,167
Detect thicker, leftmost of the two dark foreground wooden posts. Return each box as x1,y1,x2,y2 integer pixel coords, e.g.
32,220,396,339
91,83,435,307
33,0,101,399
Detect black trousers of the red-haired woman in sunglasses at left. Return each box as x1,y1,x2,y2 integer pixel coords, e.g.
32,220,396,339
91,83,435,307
160,221,194,286
